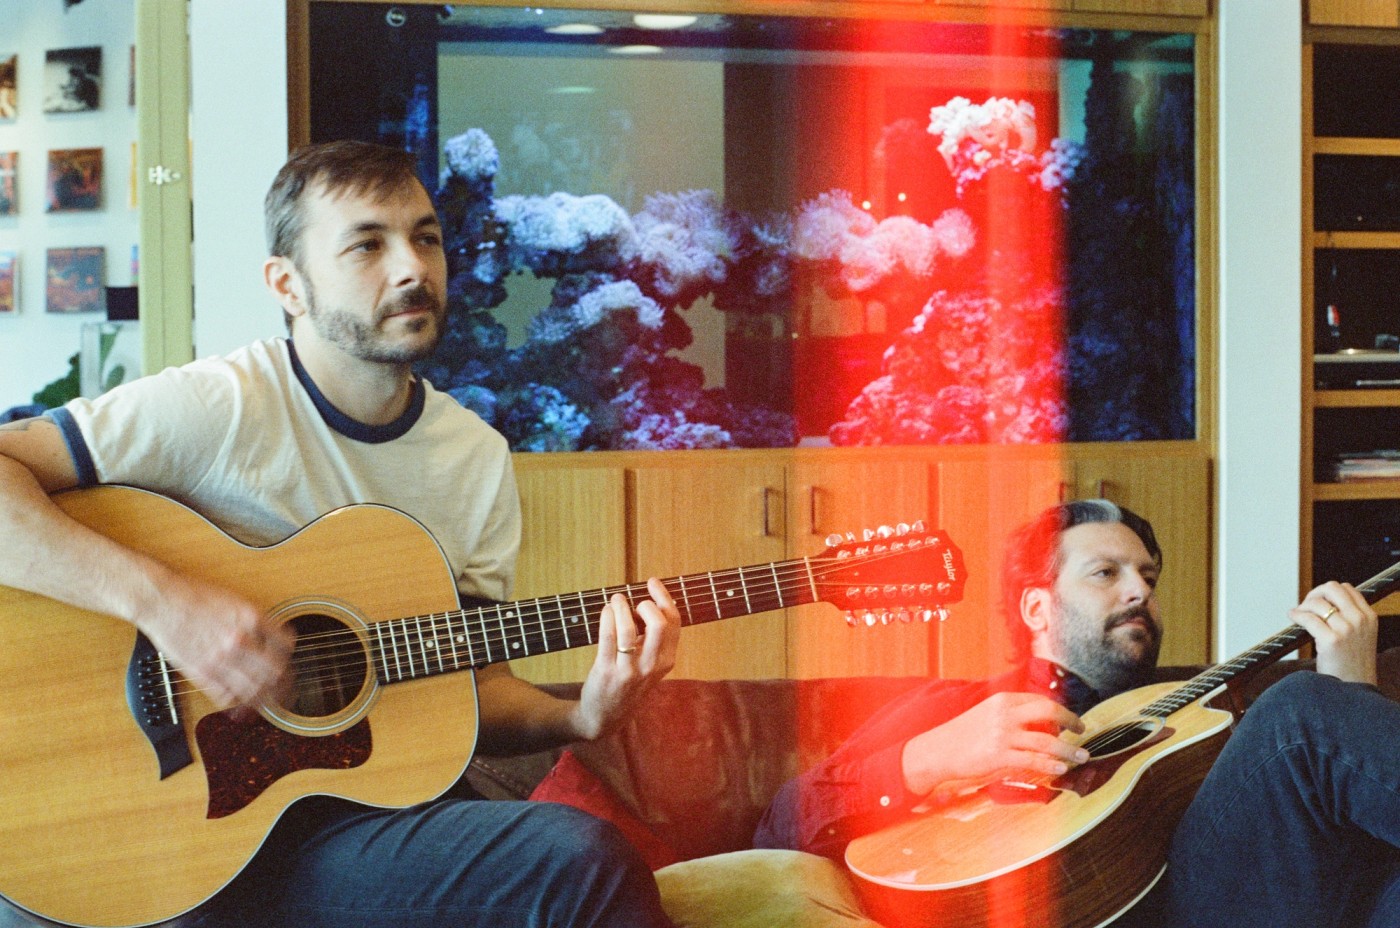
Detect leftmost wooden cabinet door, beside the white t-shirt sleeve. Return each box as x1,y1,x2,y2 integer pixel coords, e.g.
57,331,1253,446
511,462,627,683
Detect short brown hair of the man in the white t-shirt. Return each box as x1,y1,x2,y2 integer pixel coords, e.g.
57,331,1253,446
263,140,420,267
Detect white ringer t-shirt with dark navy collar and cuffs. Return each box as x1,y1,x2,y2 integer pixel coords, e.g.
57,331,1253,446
48,339,521,602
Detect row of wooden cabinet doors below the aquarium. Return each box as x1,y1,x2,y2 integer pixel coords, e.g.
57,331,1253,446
512,442,1212,682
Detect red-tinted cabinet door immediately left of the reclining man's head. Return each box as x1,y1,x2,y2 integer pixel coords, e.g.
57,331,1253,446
935,456,1074,679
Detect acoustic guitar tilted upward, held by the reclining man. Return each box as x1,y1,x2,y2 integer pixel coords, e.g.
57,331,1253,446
846,564,1400,928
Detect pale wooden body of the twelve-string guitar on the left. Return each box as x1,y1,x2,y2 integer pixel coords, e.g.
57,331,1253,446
0,487,476,925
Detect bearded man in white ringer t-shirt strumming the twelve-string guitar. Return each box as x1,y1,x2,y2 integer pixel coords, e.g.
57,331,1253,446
0,141,679,928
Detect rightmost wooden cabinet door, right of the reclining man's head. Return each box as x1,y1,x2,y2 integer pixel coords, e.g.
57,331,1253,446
1078,455,1212,666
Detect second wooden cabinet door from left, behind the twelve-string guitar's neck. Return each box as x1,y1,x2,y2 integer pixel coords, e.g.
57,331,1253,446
629,458,787,680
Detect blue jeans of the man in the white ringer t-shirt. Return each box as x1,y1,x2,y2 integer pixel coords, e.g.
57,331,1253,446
183,798,671,928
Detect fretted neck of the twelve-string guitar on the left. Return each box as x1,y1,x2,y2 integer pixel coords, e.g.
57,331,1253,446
370,557,820,683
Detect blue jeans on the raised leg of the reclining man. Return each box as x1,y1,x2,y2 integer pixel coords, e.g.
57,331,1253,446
1123,672,1400,928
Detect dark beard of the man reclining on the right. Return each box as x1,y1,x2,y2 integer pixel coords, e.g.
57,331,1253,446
1053,598,1162,697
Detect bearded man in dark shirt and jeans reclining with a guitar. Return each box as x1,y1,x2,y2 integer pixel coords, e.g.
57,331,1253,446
755,500,1400,928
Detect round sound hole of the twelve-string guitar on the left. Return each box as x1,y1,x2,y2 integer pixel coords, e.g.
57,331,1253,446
281,613,370,718
